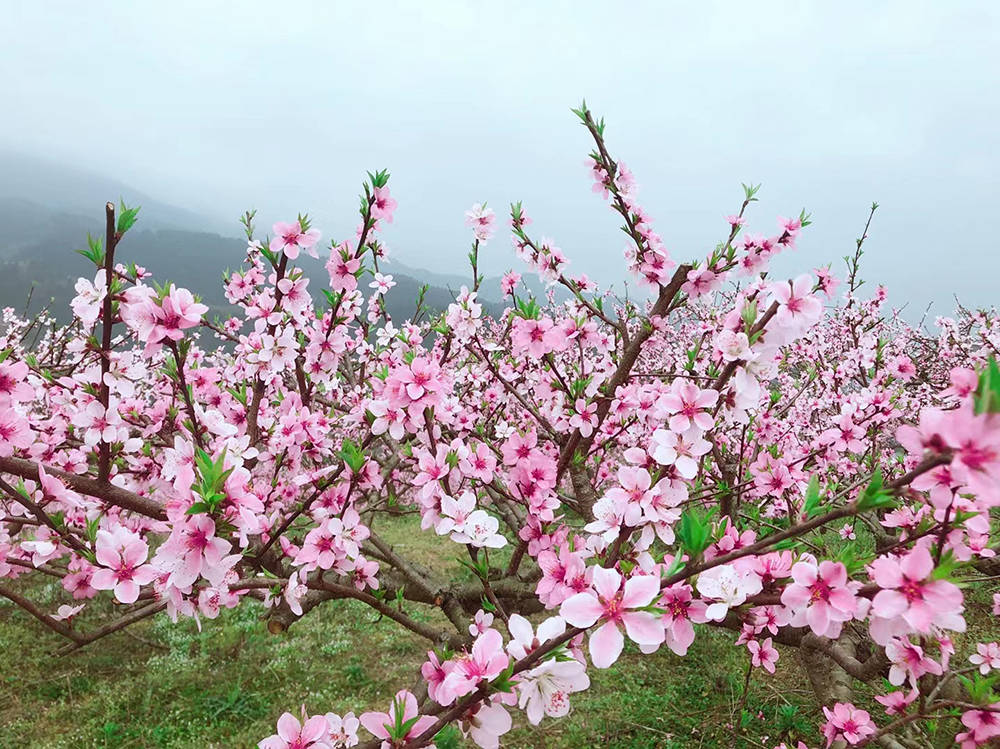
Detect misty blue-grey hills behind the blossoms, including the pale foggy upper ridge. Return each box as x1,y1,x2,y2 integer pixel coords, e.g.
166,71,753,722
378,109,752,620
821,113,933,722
0,152,512,323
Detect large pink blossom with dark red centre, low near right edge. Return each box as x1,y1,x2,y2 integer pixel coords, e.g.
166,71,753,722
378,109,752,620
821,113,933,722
870,546,965,635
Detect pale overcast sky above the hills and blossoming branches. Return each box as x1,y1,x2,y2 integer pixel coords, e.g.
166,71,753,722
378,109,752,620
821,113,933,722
0,0,1000,313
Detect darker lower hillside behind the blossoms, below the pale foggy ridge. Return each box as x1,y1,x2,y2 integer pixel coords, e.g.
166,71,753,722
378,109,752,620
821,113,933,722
0,198,508,322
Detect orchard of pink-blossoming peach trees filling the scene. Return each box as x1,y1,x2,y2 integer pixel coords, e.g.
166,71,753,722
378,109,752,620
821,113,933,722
0,107,1000,749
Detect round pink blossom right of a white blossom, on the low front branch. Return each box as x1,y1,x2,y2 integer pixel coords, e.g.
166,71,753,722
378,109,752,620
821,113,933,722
781,561,858,638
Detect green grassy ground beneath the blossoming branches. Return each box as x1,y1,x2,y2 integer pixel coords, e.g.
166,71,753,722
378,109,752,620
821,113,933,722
0,520,968,749
